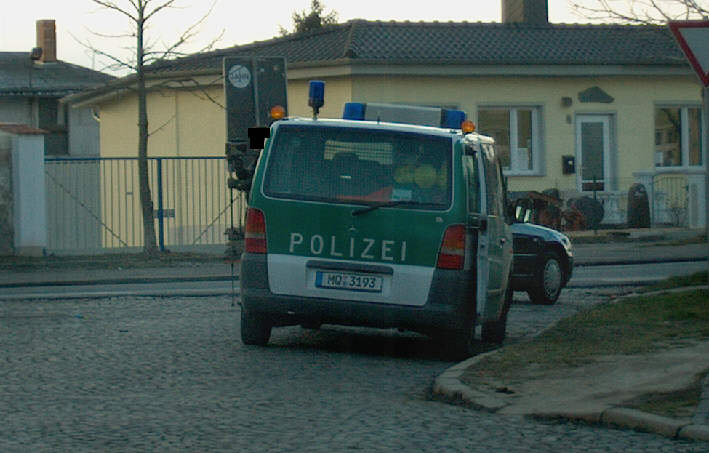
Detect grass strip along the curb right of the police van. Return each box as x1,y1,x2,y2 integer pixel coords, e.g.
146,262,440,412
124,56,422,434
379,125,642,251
463,290,709,380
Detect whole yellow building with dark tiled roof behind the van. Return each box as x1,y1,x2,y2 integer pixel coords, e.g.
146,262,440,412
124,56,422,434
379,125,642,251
63,0,706,226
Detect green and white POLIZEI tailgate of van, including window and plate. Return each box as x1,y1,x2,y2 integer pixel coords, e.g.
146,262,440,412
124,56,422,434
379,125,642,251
251,121,452,306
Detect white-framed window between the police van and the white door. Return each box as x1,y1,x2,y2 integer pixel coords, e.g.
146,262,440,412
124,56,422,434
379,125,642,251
478,107,542,175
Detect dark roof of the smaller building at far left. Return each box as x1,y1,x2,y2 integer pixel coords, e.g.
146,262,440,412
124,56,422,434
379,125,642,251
0,52,114,97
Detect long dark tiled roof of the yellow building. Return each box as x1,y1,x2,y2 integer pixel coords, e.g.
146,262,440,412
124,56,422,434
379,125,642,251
151,20,686,72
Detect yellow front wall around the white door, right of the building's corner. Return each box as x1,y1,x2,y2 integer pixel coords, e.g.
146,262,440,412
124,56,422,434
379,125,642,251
352,76,701,191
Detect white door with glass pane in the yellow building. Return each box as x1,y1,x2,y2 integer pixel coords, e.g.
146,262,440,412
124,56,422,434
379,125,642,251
576,115,611,192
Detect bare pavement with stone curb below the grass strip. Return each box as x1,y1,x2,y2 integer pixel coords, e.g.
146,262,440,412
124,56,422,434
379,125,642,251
433,286,709,442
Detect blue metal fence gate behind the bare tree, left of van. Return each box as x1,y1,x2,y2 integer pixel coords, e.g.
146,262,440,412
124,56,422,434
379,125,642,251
45,157,246,254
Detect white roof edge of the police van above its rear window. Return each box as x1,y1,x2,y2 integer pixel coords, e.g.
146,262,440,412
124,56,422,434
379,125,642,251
274,117,494,143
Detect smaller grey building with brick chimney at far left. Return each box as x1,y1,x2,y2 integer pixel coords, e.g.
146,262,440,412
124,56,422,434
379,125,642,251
0,20,114,155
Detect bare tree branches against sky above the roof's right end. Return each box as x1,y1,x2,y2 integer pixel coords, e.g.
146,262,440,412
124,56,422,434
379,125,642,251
571,0,709,24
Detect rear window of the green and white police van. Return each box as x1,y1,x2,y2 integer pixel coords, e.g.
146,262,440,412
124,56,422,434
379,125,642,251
264,125,452,210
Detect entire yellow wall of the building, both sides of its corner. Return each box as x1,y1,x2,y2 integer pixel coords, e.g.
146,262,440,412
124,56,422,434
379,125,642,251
101,70,701,194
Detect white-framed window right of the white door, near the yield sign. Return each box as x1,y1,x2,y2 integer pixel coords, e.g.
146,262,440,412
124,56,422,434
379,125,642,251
655,106,703,167
